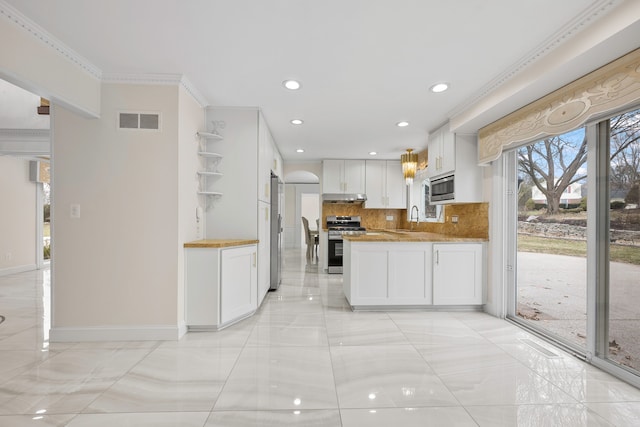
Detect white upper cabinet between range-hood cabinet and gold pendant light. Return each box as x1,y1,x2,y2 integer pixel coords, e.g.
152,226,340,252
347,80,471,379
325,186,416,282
365,160,407,209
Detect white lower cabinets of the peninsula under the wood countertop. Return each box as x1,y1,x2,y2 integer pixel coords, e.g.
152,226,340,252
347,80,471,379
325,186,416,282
343,239,484,309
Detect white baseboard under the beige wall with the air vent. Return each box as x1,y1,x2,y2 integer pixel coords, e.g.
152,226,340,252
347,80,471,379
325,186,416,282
49,322,187,342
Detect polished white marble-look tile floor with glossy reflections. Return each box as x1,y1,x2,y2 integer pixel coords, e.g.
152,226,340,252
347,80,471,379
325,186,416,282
0,250,640,427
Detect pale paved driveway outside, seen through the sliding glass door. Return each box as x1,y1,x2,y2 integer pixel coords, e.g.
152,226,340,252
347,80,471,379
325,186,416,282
517,252,640,370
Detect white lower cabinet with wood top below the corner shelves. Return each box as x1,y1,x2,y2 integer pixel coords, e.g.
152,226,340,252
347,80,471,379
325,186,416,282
185,245,258,329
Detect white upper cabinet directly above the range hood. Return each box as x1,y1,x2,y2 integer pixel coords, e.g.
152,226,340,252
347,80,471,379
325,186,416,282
322,160,365,194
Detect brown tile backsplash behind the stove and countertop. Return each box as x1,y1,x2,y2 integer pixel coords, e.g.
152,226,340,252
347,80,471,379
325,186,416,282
321,203,489,239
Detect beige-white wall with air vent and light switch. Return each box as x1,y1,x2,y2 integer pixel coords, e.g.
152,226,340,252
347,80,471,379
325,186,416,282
51,84,186,341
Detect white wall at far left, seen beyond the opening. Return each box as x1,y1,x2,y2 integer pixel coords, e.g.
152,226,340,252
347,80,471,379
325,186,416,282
0,156,37,275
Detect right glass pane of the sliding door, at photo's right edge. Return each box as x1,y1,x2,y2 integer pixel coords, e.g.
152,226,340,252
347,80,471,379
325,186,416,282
599,109,640,372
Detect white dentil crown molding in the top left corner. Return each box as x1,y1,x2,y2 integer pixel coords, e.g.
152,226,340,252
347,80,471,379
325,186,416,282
0,0,102,79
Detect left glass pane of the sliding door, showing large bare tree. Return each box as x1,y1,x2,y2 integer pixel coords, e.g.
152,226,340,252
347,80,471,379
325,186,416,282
515,128,587,353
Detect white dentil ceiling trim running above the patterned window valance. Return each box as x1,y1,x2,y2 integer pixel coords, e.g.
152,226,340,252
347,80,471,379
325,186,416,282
447,0,623,118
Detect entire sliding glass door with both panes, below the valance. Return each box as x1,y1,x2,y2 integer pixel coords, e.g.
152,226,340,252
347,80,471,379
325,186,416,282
505,105,640,384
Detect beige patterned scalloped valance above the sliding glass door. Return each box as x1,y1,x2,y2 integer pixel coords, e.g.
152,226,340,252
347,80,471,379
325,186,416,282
478,49,640,164
